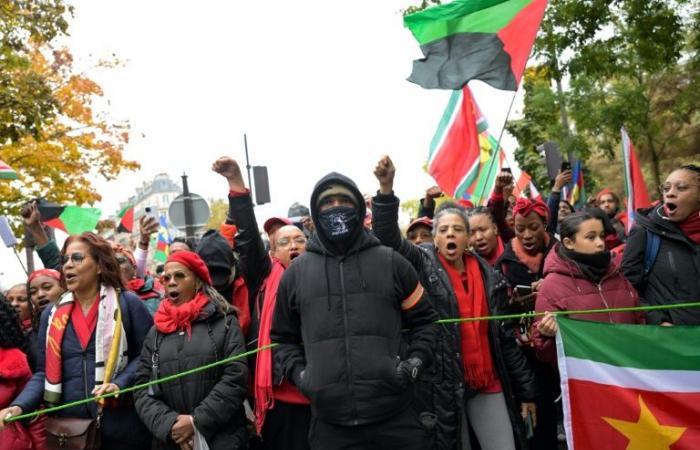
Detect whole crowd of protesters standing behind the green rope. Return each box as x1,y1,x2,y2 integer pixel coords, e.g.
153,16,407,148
0,157,700,450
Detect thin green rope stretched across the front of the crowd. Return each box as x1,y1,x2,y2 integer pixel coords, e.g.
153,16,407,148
4,302,700,423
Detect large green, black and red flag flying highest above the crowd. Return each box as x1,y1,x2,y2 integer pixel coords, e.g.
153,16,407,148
404,0,547,91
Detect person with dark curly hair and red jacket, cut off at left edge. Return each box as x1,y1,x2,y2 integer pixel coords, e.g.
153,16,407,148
0,294,46,450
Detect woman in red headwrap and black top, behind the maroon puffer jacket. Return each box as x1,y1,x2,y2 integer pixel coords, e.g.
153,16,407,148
496,198,559,450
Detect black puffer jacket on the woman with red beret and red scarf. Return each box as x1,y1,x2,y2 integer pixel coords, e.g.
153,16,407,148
135,303,248,450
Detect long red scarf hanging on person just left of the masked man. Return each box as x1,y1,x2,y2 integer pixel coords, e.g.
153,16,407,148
254,258,309,433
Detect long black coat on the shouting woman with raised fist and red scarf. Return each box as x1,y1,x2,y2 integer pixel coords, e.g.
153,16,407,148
372,194,538,449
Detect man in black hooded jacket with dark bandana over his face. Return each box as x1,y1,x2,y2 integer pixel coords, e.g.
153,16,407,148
270,173,438,450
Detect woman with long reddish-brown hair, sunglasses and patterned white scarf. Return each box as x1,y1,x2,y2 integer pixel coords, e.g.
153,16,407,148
0,232,153,450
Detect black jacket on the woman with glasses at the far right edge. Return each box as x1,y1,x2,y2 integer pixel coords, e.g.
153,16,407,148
622,206,700,325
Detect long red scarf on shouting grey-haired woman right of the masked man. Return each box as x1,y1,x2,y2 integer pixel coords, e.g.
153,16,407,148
438,254,500,391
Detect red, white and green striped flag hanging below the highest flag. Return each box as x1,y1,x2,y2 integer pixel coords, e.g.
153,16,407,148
428,86,488,198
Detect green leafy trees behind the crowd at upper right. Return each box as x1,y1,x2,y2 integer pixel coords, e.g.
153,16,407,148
508,0,700,197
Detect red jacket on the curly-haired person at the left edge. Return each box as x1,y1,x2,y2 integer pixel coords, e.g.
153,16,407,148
0,348,46,450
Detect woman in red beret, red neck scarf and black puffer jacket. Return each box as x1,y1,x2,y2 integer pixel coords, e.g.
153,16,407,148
135,250,248,450
